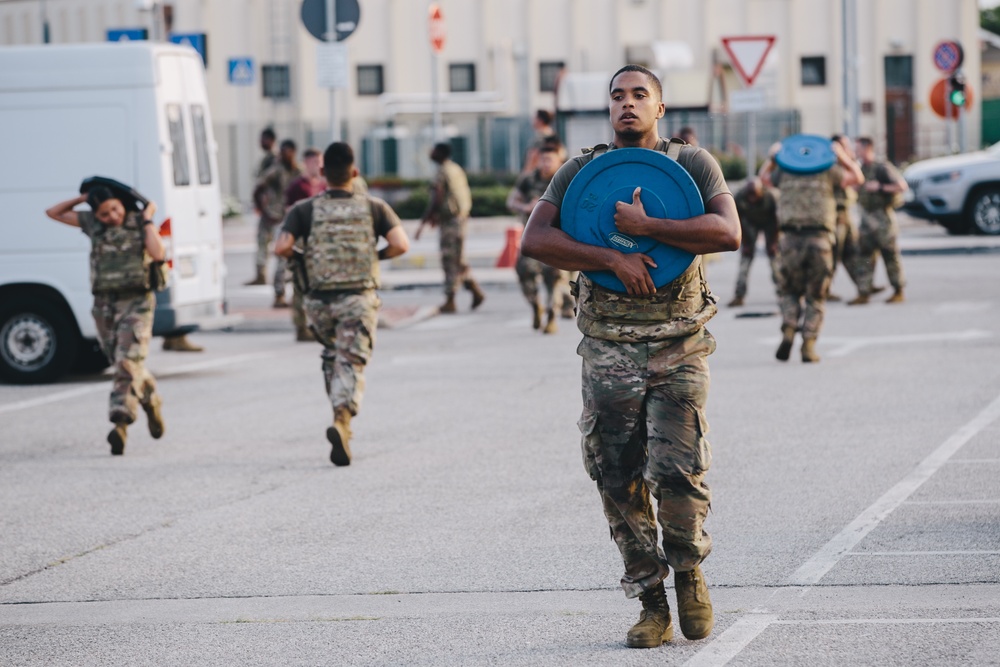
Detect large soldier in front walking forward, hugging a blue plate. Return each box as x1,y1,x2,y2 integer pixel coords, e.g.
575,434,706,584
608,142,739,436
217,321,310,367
522,65,740,648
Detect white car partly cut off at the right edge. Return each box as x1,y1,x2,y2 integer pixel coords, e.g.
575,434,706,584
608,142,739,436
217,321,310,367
903,143,1000,234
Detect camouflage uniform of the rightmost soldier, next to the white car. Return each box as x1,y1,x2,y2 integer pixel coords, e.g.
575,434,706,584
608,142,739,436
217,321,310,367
856,162,906,294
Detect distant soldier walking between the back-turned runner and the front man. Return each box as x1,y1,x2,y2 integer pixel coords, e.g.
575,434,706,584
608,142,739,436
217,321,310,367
415,142,486,314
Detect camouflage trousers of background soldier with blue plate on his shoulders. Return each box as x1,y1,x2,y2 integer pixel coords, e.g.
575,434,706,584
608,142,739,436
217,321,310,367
781,230,833,338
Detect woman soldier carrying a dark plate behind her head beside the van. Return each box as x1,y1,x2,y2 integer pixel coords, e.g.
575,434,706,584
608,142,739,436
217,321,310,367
45,185,166,456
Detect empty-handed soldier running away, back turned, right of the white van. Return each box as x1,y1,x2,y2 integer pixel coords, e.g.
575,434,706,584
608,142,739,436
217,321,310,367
274,142,409,466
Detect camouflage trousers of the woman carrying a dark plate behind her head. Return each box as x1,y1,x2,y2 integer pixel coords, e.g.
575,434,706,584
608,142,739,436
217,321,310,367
91,292,156,424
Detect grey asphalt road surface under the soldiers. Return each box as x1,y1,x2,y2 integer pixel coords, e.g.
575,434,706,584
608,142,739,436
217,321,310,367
0,218,1000,667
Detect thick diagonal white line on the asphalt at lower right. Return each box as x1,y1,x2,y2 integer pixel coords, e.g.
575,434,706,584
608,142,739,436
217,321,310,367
686,396,1000,667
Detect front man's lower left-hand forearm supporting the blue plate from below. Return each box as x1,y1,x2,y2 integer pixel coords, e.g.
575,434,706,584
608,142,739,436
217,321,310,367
521,199,656,294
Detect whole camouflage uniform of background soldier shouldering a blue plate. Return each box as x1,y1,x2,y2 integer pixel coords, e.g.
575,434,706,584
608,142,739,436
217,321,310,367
772,167,843,339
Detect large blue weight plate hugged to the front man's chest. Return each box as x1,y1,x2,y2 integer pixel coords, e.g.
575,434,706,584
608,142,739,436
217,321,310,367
559,148,705,292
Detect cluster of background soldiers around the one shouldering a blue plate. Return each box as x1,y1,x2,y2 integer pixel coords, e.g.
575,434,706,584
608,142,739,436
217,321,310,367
729,135,907,362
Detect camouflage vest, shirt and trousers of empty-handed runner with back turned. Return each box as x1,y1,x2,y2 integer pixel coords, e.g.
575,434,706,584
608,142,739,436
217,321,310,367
283,190,399,415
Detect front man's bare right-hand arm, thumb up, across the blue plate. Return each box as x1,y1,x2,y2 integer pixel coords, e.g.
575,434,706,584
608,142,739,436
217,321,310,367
615,188,743,255
